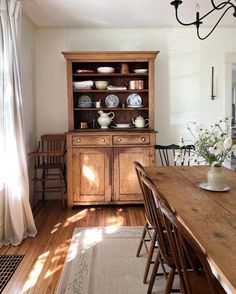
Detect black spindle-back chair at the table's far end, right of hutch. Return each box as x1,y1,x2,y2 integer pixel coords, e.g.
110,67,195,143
155,144,195,166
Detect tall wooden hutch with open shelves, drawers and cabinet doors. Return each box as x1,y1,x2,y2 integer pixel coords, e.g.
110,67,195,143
63,51,158,207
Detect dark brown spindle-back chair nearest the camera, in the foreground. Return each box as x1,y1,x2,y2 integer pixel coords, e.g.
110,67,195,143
159,201,226,294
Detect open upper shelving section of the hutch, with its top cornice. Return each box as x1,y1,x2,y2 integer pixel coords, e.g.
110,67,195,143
63,51,158,131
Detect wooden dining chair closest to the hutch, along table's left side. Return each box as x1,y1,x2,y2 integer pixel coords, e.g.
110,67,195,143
134,161,157,284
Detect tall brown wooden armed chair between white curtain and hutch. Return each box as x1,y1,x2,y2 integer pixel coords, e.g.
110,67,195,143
29,134,67,208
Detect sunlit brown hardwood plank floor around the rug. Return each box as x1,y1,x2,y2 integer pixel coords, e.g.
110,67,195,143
0,201,145,294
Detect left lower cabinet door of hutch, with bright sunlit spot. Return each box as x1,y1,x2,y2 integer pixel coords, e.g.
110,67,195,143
72,147,112,203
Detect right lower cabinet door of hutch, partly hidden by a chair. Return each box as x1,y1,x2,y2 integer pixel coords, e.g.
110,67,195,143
113,147,154,202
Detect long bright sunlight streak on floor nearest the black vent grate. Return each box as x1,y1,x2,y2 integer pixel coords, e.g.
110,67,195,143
22,251,50,293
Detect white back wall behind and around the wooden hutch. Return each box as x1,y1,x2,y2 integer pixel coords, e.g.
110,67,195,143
36,28,236,144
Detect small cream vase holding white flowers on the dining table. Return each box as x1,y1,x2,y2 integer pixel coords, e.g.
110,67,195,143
207,166,225,190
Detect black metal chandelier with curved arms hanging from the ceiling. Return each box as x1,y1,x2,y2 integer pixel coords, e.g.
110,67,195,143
170,0,236,40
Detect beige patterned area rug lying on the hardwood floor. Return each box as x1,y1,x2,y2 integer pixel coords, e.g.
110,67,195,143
56,227,171,294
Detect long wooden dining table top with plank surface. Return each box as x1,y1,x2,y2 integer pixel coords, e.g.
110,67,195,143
145,166,236,293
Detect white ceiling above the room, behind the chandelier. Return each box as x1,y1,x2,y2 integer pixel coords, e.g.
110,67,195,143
22,0,236,28
